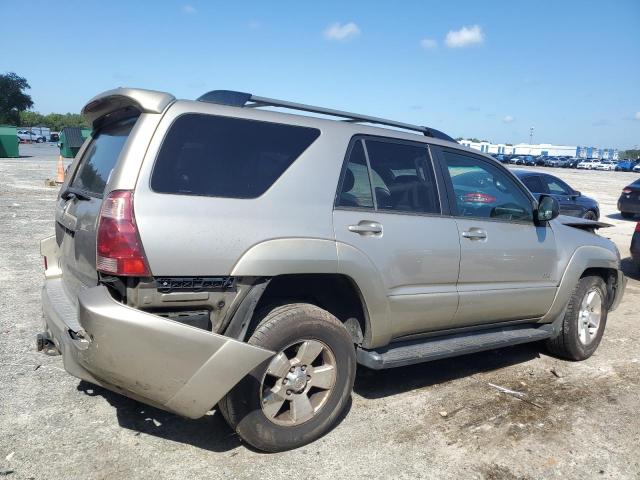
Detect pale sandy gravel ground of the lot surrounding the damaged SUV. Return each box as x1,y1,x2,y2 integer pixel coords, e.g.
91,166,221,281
0,145,640,479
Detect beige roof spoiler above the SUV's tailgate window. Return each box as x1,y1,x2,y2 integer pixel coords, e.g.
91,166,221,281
80,88,176,129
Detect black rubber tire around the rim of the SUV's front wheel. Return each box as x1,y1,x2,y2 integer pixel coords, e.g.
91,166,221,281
546,276,607,361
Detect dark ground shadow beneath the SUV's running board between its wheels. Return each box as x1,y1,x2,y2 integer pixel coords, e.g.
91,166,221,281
354,343,540,399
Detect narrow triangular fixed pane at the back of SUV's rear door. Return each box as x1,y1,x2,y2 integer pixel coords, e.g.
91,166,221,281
338,140,373,208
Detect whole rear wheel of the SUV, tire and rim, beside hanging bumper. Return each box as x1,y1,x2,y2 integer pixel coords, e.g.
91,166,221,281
219,303,356,452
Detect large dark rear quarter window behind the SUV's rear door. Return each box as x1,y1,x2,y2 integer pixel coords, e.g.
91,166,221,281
151,114,320,198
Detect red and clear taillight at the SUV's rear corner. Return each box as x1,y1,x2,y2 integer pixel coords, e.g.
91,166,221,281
96,190,151,277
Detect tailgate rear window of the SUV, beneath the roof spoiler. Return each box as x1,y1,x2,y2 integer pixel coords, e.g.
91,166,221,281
71,118,137,197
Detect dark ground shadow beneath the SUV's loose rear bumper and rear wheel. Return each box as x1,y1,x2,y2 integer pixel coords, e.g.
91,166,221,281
77,380,352,454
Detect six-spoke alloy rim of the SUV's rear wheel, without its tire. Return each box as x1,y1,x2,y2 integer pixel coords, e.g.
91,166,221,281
260,339,337,426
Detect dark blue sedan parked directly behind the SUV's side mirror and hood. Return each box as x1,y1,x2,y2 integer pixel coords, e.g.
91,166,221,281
513,170,600,220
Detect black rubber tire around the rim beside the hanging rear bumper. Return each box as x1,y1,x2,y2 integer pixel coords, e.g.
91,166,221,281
218,303,356,452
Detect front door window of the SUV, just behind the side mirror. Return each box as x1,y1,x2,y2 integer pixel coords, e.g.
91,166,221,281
444,151,533,221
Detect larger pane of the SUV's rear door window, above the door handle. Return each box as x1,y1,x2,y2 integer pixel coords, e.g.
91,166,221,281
365,140,440,213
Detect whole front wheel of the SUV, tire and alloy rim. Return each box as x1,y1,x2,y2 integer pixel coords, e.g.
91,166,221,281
546,276,607,360
